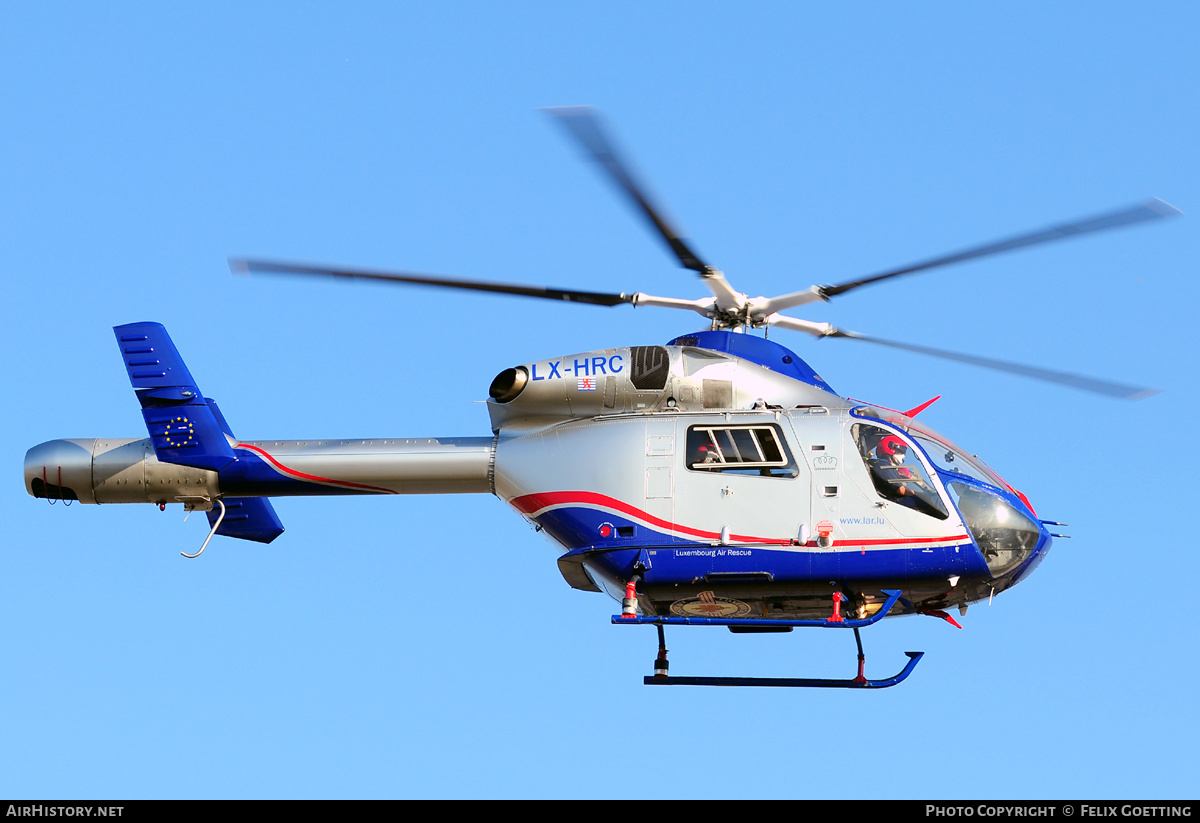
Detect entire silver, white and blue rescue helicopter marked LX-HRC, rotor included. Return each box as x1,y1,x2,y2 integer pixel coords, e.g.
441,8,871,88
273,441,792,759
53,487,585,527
25,108,1180,689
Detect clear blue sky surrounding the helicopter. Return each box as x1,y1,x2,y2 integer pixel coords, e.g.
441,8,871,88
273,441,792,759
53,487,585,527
0,2,1200,798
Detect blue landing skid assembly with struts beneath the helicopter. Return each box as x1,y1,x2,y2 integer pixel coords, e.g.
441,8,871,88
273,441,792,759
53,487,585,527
612,590,925,689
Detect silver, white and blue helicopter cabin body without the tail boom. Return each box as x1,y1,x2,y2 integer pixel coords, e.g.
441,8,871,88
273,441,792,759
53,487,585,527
493,332,1051,619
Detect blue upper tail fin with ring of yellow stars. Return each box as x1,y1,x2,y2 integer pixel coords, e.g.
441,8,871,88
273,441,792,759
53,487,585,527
113,323,236,471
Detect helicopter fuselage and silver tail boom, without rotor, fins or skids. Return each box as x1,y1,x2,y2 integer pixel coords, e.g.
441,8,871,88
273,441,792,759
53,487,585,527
25,332,1051,619
